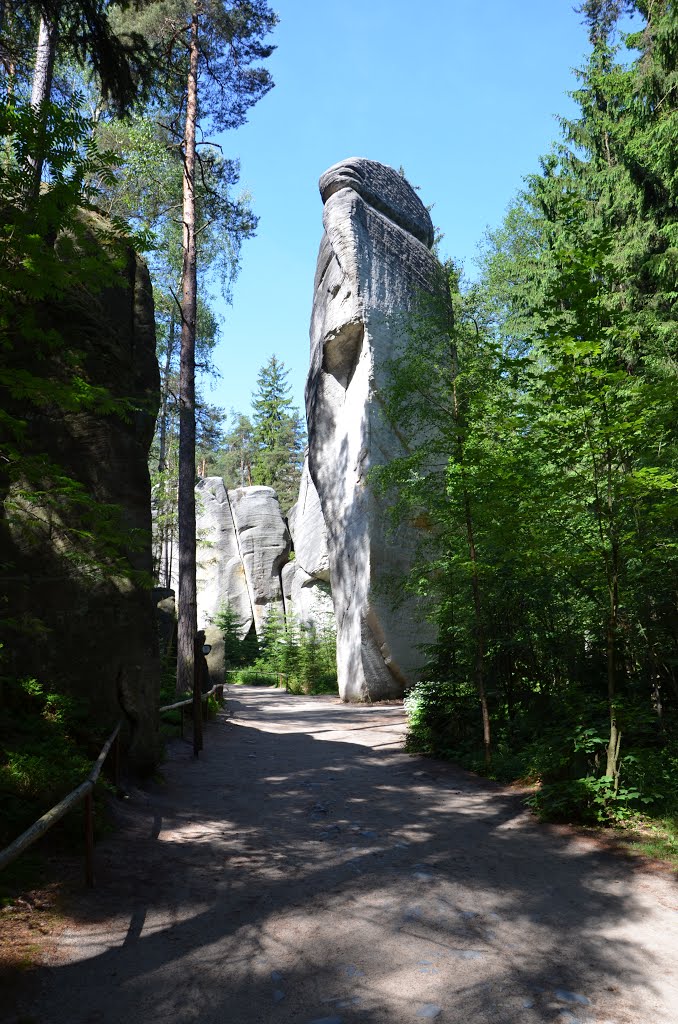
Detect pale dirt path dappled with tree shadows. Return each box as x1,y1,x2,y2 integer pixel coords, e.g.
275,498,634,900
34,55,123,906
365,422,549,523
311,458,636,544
6,688,678,1024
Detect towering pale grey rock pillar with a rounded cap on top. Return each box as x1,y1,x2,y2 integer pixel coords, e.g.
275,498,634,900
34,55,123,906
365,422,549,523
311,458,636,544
307,158,437,700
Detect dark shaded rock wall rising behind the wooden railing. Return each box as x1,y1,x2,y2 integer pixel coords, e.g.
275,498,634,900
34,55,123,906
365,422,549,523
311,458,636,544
0,214,160,769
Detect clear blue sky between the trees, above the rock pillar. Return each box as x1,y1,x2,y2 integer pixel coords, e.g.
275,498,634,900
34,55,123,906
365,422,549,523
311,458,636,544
206,0,588,412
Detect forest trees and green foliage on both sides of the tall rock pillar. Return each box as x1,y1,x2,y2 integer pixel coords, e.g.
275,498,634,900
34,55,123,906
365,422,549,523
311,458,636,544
0,0,678,864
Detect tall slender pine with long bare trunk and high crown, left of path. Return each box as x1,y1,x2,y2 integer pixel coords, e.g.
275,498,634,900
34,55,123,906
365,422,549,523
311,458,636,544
118,0,278,692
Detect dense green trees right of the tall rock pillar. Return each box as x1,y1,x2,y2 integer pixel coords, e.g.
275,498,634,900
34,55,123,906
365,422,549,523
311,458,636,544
383,0,678,823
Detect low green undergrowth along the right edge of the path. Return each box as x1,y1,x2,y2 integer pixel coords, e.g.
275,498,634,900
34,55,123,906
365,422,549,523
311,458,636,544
405,680,678,859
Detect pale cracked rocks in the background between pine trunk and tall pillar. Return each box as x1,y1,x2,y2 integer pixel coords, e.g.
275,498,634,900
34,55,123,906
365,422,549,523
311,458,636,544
196,476,291,638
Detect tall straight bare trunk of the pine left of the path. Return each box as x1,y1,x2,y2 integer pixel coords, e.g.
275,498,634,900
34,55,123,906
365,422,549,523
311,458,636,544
176,7,198,693
